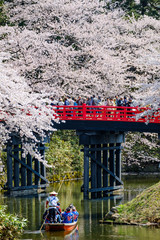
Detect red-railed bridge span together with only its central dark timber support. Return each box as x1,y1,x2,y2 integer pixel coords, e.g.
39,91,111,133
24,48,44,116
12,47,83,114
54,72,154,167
53,104,160,198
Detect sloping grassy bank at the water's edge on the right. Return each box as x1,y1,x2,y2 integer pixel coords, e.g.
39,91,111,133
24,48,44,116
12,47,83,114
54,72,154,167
105,182,160,225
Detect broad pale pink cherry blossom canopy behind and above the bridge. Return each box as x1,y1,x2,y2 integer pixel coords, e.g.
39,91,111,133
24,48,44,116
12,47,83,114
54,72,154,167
0,0,160,100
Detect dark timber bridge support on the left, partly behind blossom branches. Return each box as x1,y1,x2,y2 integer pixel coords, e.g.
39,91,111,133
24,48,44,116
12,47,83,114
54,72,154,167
5,136,48,195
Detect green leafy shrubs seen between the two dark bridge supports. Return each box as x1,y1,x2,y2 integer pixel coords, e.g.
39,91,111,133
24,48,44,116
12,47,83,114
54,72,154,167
46,130,83,180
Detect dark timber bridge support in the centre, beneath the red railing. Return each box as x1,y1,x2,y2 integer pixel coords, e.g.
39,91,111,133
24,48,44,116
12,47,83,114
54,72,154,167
77,131,124,199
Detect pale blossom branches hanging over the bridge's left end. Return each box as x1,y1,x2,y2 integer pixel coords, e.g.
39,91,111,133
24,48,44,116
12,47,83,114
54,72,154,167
0,52,56,164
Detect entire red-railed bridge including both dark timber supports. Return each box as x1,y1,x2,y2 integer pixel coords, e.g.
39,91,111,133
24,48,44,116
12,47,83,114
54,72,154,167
7,104,160,198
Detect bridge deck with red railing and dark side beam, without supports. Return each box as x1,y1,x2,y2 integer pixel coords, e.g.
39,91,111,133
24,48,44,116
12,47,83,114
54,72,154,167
54,104,160,133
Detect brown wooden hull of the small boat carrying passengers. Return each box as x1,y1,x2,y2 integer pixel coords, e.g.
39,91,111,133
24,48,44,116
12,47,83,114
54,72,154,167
44,222,77,232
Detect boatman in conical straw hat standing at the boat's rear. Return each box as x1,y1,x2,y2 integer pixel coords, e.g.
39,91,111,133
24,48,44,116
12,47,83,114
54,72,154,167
44,191,61,223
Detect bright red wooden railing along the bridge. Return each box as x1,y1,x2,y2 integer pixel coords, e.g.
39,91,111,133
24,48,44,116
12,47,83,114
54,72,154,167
53,104,160,123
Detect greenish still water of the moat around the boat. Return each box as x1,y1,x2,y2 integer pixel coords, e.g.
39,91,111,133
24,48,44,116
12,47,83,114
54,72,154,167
0,176,160,240
